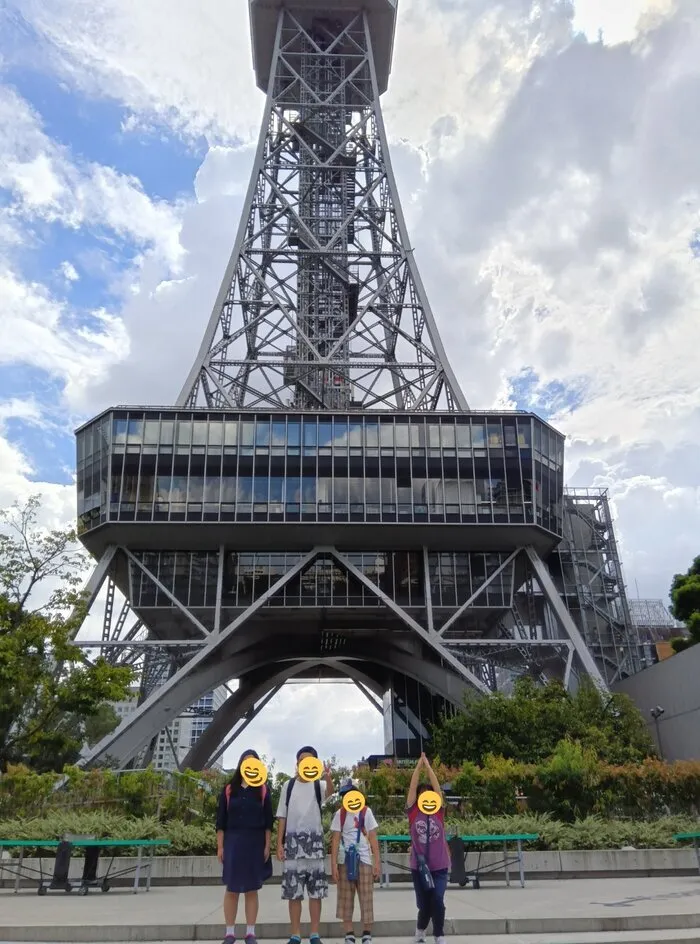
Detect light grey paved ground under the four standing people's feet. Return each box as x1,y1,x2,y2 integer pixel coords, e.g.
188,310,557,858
0,877,700,944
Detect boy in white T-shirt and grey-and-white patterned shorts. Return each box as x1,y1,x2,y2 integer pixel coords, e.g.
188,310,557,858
277,747,334,944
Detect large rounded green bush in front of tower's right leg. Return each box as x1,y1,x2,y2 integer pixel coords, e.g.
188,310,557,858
433,678,654,766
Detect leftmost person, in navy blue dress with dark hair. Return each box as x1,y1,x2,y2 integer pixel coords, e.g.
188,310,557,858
216,751,272,944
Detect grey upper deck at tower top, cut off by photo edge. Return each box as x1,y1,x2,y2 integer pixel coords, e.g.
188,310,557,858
250,0,398,95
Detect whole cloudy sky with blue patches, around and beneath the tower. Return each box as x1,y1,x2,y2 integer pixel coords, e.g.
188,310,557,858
0,0,700,766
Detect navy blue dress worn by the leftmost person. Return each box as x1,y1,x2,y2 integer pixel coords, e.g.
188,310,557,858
216,784,272,894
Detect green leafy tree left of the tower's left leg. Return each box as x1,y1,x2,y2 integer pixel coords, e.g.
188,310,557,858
0,497,133,771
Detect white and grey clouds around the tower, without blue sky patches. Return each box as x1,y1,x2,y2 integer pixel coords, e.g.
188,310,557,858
0,0,700,763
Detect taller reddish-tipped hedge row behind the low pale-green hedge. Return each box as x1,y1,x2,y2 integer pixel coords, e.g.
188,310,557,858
0,741,700,824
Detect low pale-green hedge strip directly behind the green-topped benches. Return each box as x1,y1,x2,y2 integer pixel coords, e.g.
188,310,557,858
0,812,698,856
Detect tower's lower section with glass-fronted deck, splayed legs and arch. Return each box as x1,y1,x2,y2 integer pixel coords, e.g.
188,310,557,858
71,408,638,769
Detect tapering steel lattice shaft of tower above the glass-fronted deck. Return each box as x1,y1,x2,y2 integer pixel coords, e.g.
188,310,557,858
178,4,468,411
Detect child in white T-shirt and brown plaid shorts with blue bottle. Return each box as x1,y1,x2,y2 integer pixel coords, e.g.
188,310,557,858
331,780,381,944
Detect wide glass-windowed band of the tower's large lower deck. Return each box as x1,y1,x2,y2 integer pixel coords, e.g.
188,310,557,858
77,410,564,535
